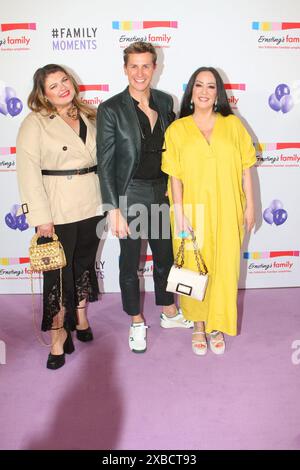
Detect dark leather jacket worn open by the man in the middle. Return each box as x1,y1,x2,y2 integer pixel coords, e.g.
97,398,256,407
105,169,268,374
97,87,175,210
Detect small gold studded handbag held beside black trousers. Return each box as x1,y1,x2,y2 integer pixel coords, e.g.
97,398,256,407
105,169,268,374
29,233,67,272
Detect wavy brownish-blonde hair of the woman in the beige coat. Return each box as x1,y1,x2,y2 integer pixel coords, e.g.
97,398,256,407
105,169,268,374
27,64,96,120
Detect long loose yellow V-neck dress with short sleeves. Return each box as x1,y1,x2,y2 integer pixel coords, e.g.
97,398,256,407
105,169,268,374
162,113,256,335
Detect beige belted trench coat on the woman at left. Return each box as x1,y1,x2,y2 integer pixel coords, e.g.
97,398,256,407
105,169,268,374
17,112,103,226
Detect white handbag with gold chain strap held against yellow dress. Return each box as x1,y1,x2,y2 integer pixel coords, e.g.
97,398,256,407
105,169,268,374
166,233,208,301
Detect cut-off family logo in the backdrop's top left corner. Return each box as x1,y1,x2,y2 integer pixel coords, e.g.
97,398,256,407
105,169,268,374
0,23,36,52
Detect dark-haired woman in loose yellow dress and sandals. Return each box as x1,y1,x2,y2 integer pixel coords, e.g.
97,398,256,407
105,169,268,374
162,67,256,355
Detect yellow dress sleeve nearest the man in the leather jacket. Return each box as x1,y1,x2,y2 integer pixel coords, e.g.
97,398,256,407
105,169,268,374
161,125,182,179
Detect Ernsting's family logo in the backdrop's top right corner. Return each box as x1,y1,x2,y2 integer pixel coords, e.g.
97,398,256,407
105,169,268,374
252,21,300,50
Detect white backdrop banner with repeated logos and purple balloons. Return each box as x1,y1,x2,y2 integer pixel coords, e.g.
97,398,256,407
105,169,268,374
0,0,300,293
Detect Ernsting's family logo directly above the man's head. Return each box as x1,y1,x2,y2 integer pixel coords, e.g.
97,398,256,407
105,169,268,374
112,21,178,48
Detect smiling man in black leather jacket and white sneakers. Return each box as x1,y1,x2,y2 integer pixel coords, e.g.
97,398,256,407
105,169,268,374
97,42,192,352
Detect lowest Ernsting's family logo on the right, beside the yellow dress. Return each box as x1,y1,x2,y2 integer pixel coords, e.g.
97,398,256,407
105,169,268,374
244,250,300,274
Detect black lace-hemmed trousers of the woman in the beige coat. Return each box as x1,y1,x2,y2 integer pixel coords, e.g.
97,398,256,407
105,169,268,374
42,217,102,331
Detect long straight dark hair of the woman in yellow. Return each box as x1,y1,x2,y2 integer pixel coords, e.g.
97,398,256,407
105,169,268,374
179,67,233,117
